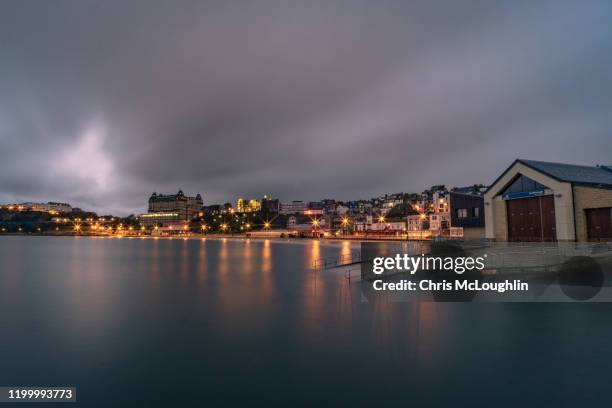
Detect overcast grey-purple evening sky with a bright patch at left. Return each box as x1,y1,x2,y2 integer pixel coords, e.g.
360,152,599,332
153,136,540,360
0,0,612,215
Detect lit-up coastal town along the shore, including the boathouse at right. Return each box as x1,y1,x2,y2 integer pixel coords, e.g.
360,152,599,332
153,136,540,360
0,159,612,242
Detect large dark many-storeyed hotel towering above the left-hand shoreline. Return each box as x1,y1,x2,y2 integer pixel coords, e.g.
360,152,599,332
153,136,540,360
138,190,204,227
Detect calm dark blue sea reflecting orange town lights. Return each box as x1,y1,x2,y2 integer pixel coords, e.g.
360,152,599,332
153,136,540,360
0,237,612,407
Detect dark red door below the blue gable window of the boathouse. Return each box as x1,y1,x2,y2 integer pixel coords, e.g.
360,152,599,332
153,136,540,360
507,195,557,242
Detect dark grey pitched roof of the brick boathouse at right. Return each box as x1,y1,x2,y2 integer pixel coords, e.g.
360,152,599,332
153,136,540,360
517,159,612,185
